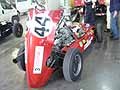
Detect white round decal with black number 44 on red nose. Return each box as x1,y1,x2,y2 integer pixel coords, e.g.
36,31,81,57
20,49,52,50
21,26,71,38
29,13,53,38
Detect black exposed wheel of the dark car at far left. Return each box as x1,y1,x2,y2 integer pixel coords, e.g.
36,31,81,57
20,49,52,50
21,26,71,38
12,23,23,38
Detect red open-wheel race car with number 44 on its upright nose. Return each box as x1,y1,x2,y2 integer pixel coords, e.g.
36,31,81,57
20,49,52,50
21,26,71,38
13,1,94,88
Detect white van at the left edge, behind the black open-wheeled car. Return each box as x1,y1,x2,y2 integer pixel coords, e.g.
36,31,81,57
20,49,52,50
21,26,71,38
0,1,19,24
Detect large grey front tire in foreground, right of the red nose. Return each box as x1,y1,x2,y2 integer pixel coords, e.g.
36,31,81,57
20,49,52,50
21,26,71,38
63,49,83,82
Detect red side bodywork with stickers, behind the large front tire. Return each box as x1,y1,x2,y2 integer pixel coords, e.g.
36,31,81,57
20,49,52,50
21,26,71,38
62,24,94,53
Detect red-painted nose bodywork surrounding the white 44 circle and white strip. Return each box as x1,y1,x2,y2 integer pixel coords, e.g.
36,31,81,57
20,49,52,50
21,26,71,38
25,9,61,87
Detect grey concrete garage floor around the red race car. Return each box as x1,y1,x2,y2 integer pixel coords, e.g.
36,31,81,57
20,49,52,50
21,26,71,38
0,15,120,90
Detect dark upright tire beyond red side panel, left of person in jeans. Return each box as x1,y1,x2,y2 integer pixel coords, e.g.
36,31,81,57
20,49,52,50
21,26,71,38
96,22,104,42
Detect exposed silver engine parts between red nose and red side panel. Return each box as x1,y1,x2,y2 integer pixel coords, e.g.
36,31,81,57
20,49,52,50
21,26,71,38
54,13,84,51
